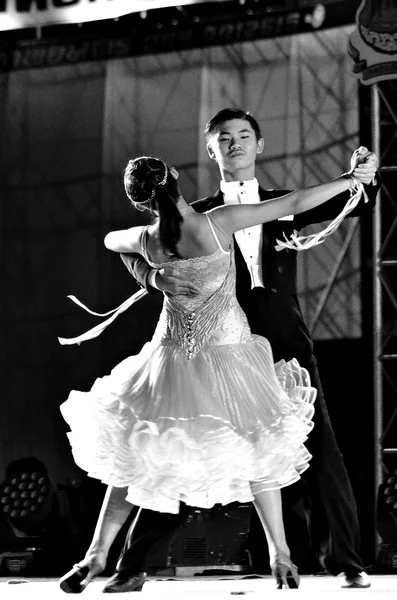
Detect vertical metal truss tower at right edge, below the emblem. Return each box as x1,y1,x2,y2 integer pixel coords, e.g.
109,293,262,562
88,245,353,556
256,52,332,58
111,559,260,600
371,80,397,520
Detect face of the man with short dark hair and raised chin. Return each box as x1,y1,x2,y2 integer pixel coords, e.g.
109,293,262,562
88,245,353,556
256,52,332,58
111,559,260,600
207,119,263,177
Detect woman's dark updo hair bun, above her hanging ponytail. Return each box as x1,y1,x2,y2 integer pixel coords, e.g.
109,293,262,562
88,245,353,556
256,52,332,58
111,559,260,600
124,156,168,211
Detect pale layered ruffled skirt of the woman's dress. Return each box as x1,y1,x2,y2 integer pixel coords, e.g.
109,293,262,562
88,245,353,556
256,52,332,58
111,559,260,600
61,335,316,513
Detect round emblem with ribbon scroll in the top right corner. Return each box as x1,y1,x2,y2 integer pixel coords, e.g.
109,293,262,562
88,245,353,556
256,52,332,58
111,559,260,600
349,0,397,85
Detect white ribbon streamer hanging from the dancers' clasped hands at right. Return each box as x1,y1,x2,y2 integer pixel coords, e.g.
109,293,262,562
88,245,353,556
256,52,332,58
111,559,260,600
275,180,366,252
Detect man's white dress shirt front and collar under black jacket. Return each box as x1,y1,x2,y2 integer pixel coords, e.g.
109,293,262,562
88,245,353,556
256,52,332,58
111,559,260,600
220,178,265,288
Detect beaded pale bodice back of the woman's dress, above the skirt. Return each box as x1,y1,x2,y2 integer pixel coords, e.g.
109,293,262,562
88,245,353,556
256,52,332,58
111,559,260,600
145,226,251,360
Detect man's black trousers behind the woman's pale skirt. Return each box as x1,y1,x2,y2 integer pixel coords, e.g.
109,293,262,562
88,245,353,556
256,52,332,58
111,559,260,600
117,289,364,575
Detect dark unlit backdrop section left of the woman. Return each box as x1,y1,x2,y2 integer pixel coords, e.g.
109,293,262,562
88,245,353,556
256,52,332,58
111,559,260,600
0,65,159,483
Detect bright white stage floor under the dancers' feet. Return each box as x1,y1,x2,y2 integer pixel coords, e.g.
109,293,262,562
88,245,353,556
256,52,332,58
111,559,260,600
0,575,397,600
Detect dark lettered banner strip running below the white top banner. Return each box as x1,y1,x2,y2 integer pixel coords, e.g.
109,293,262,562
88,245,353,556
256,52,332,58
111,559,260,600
0,0,357,73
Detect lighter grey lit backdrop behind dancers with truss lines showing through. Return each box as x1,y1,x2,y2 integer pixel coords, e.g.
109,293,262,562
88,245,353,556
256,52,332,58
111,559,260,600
103,27,361,339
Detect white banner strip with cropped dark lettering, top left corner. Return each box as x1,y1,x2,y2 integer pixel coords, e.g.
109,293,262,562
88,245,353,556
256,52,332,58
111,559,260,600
0,0,232,31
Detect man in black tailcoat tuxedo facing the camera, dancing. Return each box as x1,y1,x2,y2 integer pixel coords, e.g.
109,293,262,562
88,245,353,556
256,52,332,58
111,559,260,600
99,109,379,592
